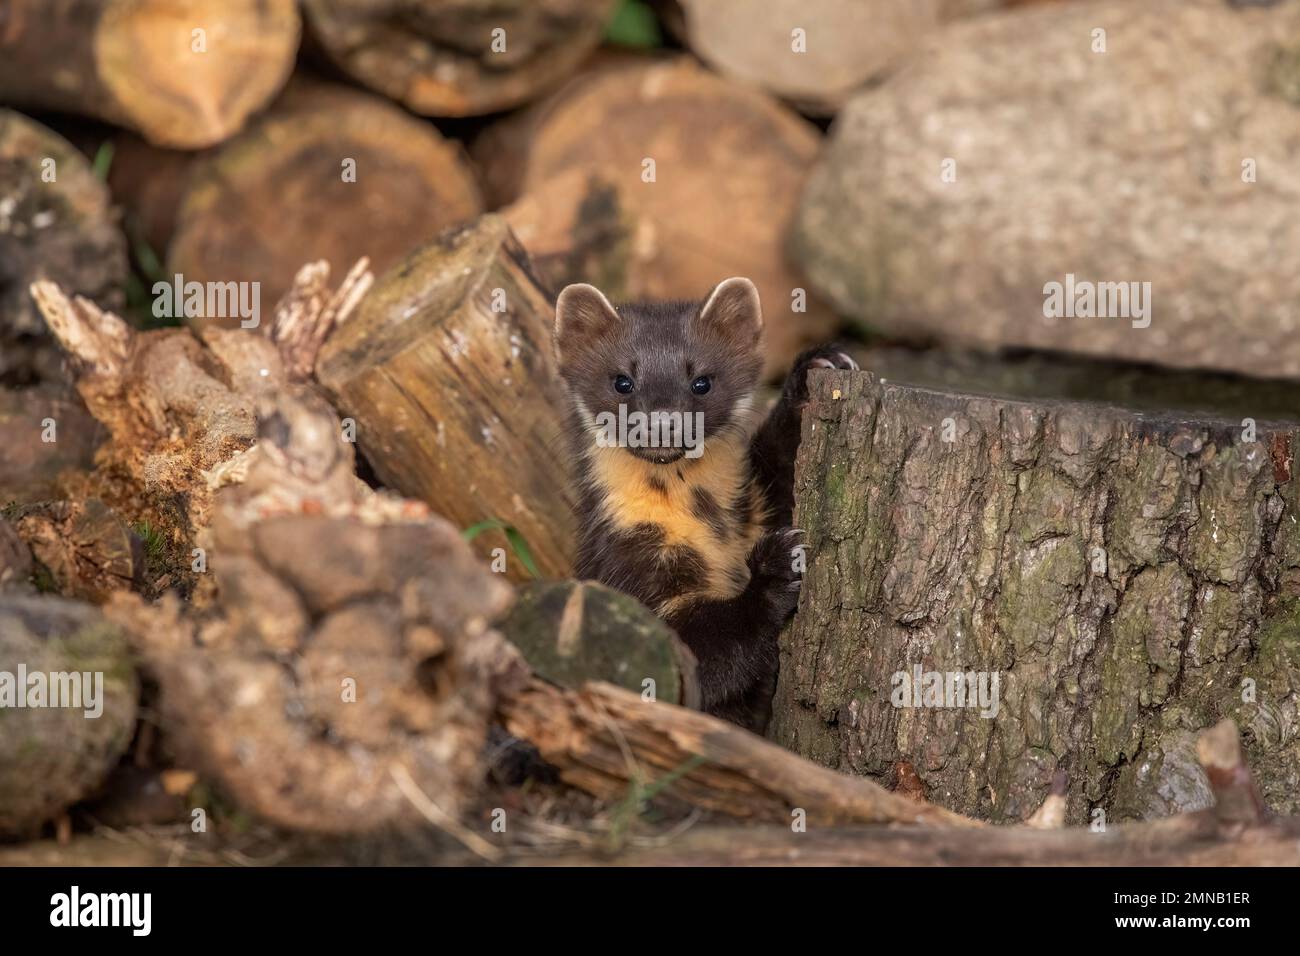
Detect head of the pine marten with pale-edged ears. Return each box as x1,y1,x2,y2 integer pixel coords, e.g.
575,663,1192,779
555,278,763,464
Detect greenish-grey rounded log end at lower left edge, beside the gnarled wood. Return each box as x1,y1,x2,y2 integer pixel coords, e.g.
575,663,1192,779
0,594,139,836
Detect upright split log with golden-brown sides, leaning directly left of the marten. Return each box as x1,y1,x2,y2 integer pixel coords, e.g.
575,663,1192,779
316,216,573,579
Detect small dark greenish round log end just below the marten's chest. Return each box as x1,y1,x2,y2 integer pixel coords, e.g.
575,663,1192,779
501,581,699,709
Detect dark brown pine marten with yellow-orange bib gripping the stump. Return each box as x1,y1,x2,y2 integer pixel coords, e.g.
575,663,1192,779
555,278,857,732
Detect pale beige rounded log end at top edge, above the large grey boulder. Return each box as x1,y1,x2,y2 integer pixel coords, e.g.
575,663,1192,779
681,0,1009,116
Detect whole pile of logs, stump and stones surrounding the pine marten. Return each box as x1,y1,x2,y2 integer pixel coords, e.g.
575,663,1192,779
0,0,1300,866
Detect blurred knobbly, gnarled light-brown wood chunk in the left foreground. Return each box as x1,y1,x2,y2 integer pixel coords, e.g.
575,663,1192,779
109,390,521,842
